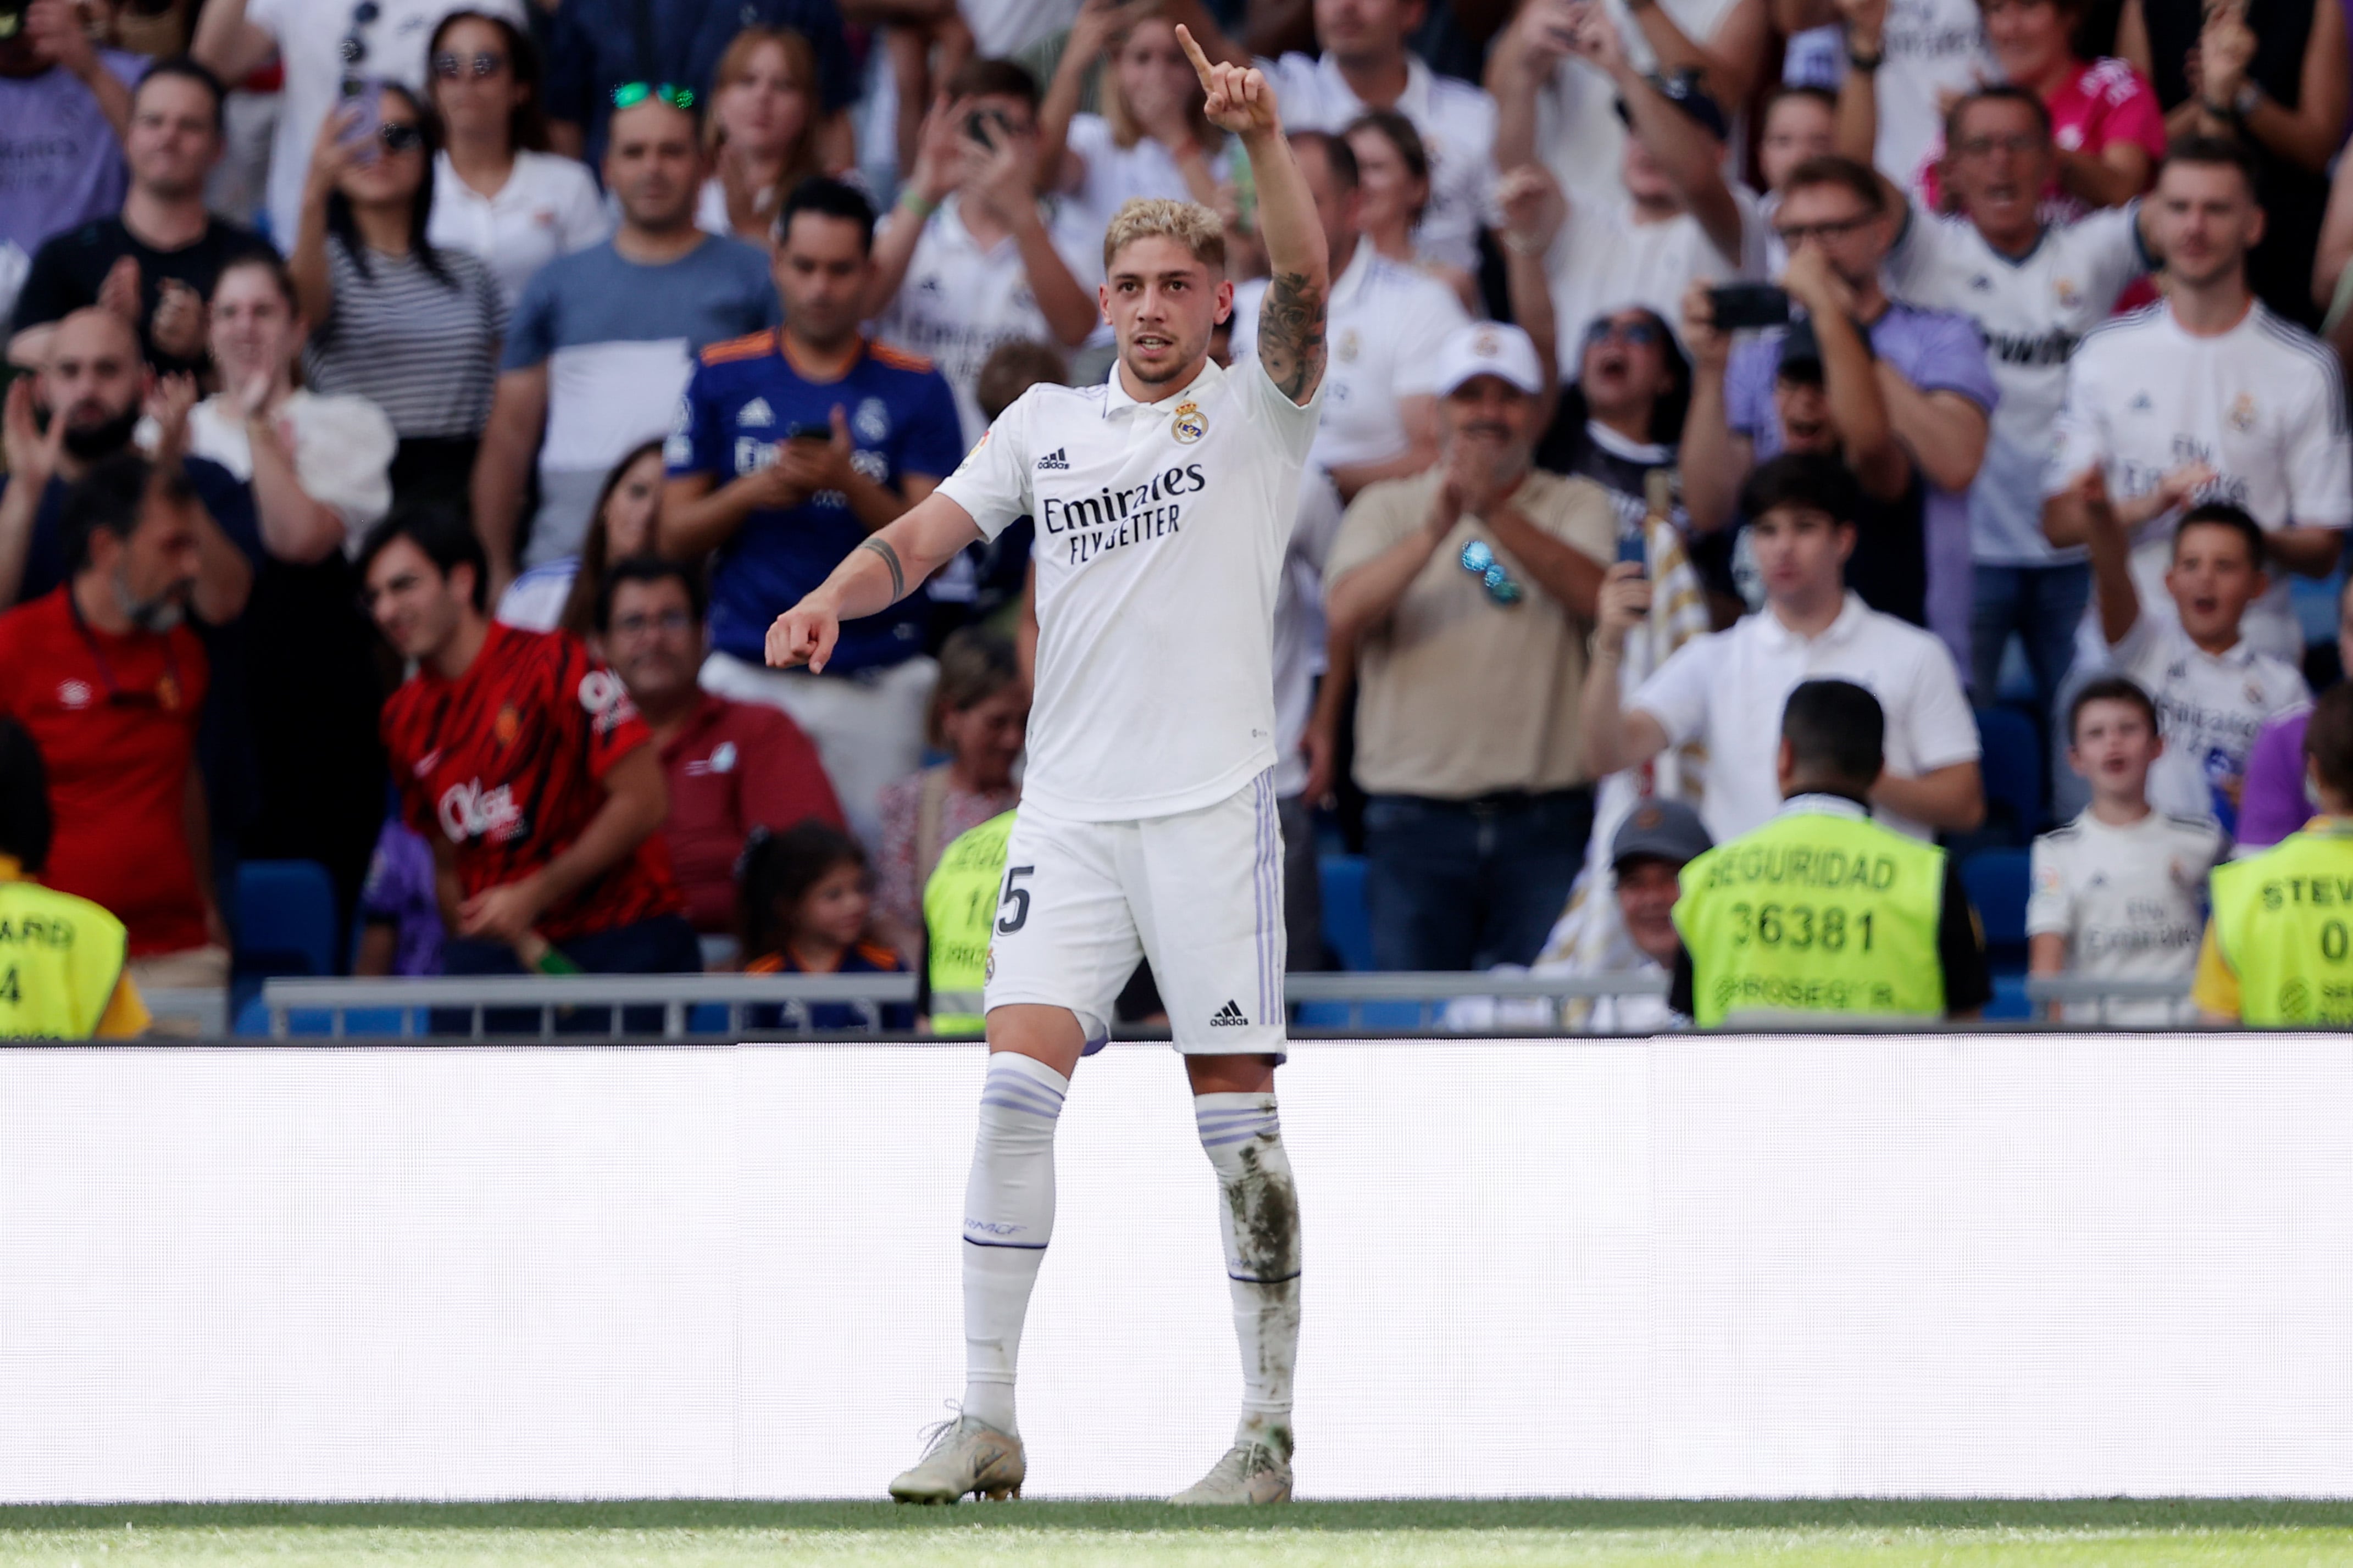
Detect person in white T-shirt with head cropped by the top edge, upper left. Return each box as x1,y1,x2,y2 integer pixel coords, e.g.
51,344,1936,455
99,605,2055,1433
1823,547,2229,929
188,0,529,249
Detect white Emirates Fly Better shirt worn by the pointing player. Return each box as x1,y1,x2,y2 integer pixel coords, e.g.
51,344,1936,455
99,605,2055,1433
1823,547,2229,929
939,362,1322,823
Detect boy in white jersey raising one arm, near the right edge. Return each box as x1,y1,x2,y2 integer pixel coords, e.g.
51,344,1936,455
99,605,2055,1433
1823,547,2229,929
2075,482,2313,832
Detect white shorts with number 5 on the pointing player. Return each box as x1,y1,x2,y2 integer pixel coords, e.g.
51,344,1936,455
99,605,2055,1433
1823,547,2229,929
986,769,1285,1055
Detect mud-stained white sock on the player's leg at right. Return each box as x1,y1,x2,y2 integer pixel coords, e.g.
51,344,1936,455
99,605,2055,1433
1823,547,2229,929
1193,1093,1299,1460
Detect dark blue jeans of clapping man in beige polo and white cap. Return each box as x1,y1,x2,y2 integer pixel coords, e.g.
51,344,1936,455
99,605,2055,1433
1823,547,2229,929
1365,790,1593,969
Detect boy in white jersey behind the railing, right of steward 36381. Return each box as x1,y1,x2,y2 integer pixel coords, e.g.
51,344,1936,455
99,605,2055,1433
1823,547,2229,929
2026,675,2226,1025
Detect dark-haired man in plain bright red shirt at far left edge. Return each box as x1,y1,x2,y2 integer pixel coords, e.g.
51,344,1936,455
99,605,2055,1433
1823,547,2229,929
0,454,228,1006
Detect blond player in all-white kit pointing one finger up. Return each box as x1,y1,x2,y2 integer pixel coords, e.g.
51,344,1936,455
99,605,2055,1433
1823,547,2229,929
767,28,1329,1502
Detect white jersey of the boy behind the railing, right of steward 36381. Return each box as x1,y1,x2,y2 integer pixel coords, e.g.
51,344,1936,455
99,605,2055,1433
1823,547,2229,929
2026,811,2223,1022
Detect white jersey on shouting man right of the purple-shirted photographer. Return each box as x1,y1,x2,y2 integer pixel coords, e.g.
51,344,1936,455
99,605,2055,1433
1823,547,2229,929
1887,202,2148,566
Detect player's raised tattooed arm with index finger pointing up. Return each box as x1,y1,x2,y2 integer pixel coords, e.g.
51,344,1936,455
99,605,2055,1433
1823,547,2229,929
1176,26,1332,404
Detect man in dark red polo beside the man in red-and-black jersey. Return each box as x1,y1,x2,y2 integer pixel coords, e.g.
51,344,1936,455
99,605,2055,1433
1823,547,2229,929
595,555,842,936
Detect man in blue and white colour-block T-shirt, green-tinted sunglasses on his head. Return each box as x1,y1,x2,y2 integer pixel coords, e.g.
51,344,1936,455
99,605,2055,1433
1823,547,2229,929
473,82,779,592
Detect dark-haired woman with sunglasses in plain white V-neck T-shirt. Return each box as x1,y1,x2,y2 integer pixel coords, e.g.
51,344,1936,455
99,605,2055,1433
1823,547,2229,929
426,12,612,308
